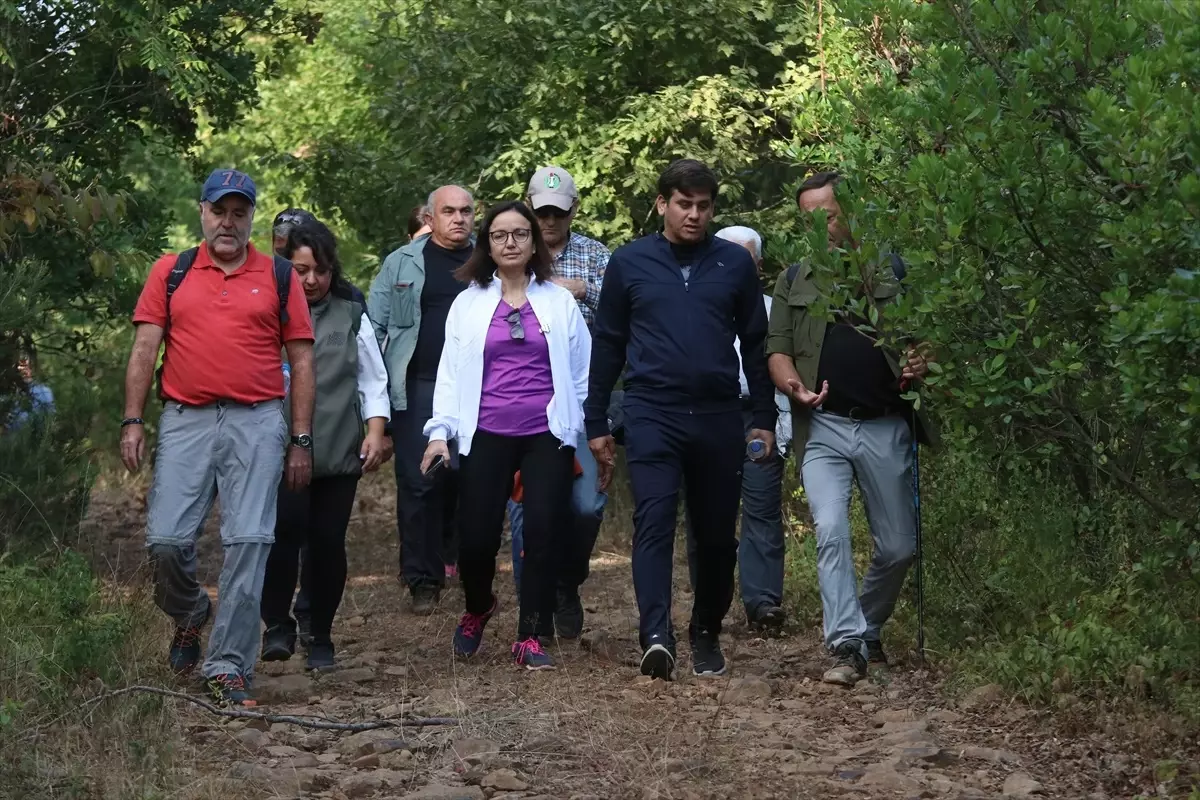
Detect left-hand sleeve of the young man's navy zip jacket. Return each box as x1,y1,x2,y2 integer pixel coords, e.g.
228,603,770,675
583,249,629,439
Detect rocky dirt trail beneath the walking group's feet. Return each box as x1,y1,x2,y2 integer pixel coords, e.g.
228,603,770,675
82,477,1161,800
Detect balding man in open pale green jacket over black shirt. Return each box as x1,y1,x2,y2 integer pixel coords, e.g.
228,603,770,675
367,186,475,615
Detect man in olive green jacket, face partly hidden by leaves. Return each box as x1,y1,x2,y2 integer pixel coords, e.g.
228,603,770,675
767,173,935,685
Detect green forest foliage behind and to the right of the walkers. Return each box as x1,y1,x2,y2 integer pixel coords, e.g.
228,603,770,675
0,0,1200,709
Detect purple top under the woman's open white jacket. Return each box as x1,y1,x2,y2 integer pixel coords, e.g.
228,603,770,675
479,300,554,437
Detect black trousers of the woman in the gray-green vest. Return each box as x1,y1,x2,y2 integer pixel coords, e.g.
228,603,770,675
262,475,359,643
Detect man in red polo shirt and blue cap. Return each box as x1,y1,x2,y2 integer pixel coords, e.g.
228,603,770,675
121,169,314,705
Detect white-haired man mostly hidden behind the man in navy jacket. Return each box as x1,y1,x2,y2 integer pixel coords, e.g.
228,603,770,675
688,225,792,633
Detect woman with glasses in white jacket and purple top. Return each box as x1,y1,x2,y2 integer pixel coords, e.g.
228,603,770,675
421,203,592,669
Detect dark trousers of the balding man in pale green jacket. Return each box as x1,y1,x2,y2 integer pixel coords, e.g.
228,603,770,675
391,378,458,590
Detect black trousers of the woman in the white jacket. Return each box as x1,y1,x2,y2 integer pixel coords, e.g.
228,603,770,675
458,431,575,638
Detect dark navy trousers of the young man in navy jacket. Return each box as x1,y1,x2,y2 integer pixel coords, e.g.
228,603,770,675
625,407,745,648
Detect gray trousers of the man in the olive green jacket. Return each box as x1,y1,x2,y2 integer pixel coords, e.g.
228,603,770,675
800,411,917,657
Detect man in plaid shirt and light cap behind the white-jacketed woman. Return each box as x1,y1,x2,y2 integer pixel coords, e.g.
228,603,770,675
509,167,608,639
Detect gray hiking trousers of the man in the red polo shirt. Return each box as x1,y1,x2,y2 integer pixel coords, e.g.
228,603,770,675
146,401,288,678
